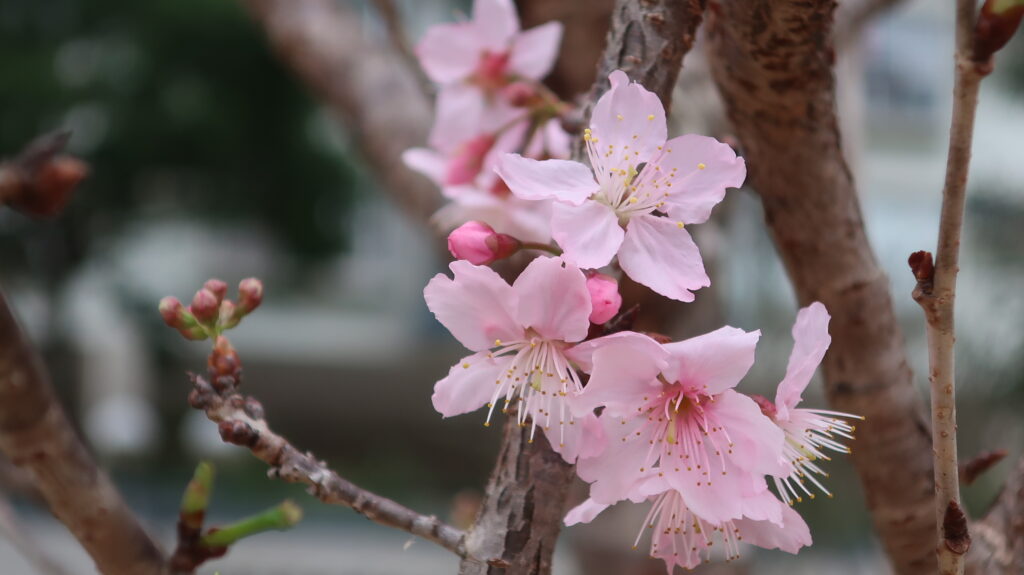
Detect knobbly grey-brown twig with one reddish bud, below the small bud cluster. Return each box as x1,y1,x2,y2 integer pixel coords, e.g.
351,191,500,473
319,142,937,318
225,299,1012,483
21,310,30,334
188,337,467,558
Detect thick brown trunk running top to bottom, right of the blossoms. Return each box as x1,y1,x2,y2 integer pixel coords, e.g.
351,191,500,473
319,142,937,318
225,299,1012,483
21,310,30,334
709,0,936,575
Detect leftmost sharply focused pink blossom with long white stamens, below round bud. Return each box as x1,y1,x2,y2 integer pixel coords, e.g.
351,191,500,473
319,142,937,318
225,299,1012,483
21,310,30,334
424,257,663,461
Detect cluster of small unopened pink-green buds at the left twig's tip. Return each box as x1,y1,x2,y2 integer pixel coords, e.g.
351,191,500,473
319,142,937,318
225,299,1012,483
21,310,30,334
160,277,263,340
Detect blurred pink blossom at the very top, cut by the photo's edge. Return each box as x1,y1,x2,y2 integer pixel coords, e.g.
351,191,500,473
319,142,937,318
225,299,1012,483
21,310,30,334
416,0,562,90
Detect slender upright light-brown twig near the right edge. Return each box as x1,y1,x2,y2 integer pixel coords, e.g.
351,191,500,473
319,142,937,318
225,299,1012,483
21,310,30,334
910,0,991,564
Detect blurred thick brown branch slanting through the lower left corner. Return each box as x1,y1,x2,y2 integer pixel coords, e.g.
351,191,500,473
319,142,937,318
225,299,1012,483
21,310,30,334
0,294,163,575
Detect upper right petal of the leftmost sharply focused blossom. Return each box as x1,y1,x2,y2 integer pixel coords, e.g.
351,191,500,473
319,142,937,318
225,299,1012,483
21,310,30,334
512,257,591,342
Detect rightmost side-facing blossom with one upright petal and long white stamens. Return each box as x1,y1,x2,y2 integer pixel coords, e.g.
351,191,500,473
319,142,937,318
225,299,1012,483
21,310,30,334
755,302,862,504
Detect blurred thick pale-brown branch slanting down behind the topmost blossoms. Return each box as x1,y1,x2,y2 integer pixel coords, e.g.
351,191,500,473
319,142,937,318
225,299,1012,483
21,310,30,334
243,0,441,224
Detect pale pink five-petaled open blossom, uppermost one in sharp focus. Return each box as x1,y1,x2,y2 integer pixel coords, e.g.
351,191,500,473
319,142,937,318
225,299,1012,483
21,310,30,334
497,71,746,302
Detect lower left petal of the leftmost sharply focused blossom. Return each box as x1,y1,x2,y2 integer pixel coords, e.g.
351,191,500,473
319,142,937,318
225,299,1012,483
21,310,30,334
430,352,507,417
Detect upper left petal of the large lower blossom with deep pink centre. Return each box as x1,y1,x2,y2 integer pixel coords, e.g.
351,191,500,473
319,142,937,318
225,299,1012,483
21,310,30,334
567,331,669,417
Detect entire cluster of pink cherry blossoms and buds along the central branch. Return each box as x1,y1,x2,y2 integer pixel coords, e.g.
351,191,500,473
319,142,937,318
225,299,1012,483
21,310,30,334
407,0,856,573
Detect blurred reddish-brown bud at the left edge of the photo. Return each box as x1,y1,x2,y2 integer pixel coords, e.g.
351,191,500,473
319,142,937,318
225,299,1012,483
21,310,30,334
0,132,89,217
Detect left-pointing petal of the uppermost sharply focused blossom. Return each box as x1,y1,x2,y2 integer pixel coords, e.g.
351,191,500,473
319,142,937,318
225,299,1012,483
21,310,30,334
495,153,600,206
